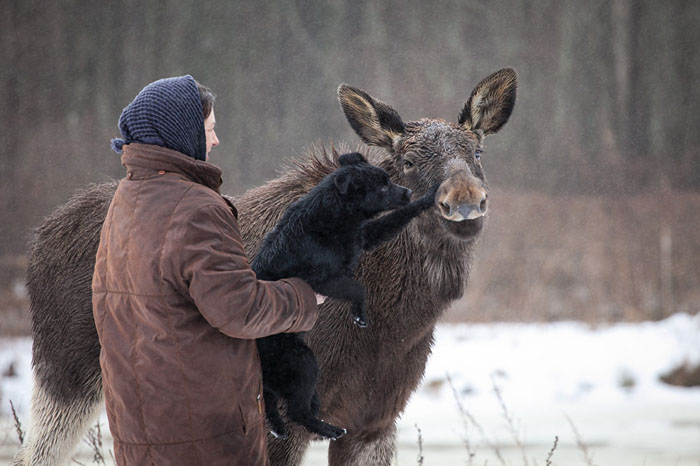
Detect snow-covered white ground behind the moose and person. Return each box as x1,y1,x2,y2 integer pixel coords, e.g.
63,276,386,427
0,314,700,466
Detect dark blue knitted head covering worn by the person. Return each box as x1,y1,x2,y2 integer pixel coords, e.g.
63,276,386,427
112,75,207,160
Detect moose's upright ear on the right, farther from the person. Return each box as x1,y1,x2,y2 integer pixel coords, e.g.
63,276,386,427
459,68,518,134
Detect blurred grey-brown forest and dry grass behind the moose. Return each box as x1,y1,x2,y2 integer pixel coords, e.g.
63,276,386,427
0,0,700,335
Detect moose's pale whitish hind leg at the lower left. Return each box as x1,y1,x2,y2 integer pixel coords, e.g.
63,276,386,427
12,379,103,466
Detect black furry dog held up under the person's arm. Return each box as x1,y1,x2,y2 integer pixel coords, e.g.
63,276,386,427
251,153,437,439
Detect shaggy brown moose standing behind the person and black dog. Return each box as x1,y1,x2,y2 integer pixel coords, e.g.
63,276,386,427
13,68,517,466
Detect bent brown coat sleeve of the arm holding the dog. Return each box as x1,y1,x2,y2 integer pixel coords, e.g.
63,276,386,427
169,200,318,339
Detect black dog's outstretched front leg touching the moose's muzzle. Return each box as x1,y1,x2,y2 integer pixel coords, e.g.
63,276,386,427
362,184,440,251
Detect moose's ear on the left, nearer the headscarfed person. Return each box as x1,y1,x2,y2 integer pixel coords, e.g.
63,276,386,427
338,84,405,148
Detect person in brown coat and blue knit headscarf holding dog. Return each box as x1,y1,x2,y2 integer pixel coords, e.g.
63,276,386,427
92,75,324,466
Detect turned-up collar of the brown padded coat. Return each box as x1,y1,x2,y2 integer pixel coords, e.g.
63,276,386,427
122,143,222,194
